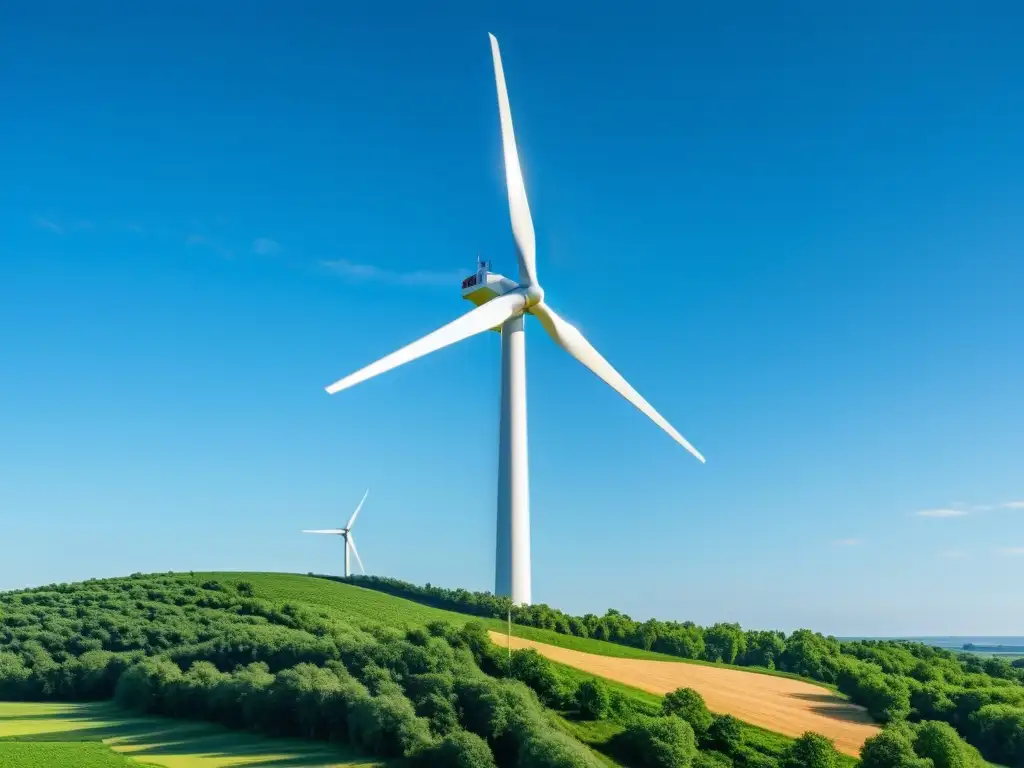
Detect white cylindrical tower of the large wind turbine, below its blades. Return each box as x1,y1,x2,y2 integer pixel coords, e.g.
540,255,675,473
495,315,531,605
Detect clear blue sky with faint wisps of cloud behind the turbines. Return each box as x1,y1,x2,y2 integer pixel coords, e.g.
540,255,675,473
0,2,1024,635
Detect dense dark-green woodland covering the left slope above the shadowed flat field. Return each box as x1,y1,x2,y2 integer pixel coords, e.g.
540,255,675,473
0,575,600,768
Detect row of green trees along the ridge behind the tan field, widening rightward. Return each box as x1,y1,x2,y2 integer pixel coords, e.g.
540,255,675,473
339,577,1024,768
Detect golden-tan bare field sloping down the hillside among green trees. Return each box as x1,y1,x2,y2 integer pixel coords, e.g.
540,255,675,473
490,632,879,756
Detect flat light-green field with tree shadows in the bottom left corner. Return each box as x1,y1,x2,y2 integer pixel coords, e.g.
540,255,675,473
0,701,384,768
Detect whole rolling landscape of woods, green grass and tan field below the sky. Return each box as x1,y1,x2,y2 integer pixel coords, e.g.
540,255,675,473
0,572,1018,768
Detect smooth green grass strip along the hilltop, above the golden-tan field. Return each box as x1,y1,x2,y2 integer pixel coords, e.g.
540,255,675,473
196,572,845,697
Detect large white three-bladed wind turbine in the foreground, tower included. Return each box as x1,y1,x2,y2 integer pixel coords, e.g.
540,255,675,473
327,35,705,605
